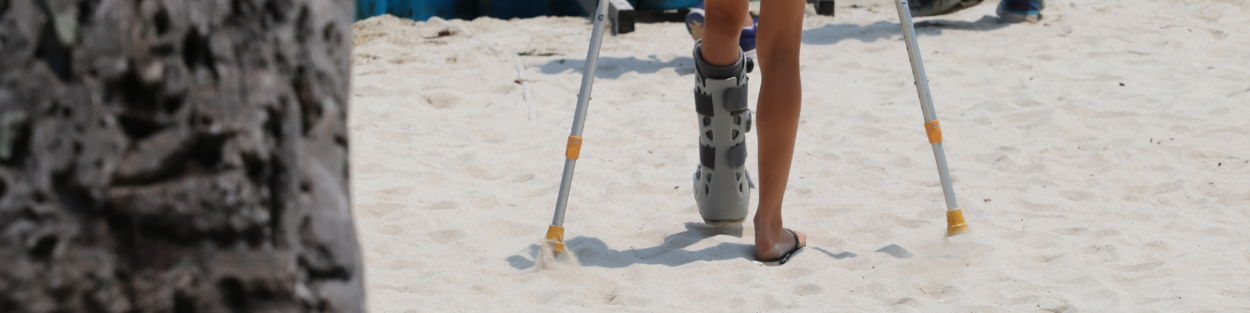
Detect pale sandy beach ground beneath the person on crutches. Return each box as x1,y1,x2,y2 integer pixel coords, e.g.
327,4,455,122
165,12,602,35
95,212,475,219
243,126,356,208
350,0,1250,312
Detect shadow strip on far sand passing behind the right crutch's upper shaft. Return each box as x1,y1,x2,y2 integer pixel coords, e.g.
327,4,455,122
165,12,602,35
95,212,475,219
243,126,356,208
803,15,1010,45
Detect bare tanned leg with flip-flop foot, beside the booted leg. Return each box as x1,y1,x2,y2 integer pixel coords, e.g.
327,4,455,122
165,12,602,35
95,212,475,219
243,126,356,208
750,0,806,259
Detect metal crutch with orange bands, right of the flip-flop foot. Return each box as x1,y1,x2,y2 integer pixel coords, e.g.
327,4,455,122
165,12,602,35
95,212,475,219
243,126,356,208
895,0,968,235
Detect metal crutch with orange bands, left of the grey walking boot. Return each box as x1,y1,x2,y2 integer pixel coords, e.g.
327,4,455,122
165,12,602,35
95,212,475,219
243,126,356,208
548,0,608,255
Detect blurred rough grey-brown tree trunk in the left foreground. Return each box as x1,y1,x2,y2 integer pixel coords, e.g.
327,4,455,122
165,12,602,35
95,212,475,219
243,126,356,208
0,0,364,313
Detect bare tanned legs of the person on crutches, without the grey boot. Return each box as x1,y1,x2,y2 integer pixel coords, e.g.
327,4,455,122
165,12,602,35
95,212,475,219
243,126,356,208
701,0,806,260
